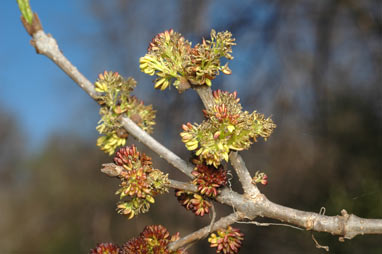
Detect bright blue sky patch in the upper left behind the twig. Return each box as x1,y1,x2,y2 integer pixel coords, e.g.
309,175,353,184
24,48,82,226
0,0,98,148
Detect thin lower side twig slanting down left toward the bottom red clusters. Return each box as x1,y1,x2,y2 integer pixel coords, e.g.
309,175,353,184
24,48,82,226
169,213,243,251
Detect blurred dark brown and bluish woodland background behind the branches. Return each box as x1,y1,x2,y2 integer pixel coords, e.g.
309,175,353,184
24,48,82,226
0,0,382,254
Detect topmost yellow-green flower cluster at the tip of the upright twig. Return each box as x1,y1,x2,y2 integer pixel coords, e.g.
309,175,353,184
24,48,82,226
139,29,235,92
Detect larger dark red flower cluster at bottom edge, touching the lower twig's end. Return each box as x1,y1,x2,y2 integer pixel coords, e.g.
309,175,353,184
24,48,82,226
121,225,186,254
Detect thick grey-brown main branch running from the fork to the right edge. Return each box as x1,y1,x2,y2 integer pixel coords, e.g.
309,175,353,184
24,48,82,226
217,191,382,239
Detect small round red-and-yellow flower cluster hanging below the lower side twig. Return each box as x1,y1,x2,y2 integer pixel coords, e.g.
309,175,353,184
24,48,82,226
208,226,244,254
